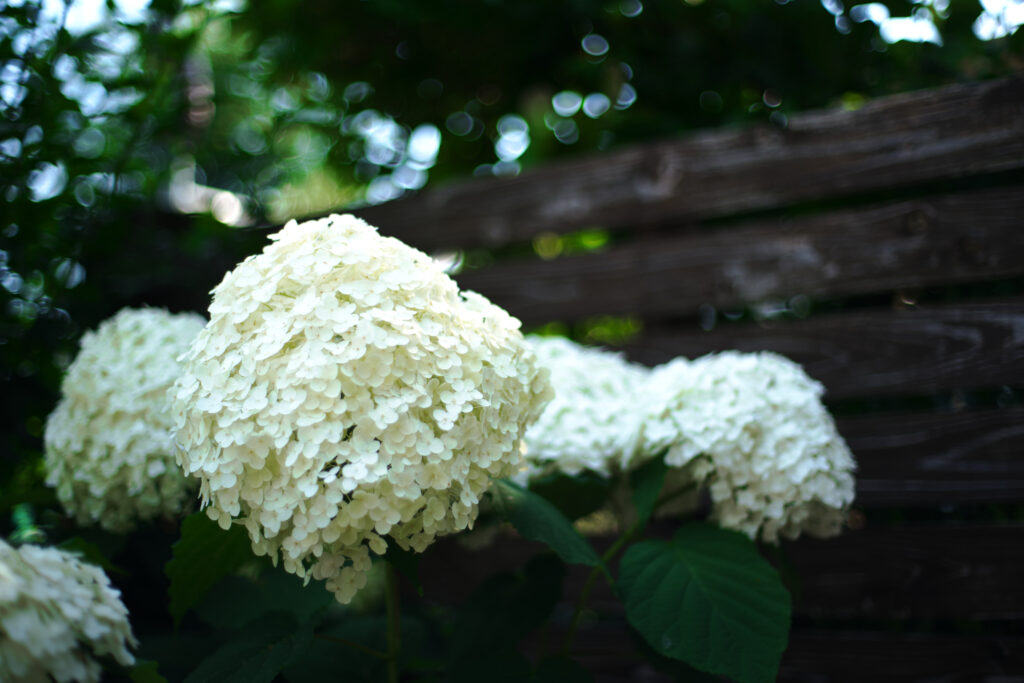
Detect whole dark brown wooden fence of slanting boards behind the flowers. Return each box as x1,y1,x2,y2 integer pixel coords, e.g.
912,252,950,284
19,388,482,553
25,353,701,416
359,77,1024,681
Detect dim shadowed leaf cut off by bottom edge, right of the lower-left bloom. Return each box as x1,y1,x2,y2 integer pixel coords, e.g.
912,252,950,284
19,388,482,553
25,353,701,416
185,612,313,683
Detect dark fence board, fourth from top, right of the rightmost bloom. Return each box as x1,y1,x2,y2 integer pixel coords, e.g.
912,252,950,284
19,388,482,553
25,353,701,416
837,408,1024,508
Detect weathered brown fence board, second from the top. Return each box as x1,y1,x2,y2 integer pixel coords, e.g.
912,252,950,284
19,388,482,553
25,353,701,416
458,185,1024,323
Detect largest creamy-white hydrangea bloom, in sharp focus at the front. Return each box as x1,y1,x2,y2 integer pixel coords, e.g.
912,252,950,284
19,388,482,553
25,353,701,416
176,215,551,602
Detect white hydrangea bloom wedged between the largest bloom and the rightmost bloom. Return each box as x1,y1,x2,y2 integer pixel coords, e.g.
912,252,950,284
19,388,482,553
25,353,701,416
523,336,650,476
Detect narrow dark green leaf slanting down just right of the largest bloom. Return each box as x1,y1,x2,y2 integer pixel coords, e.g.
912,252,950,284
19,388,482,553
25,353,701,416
490,479,601,566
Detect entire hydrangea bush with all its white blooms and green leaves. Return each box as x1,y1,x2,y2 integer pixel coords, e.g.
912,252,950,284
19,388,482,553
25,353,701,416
19,216,854,683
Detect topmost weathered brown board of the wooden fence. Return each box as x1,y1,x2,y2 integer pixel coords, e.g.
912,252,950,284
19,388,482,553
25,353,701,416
356,77,1024,250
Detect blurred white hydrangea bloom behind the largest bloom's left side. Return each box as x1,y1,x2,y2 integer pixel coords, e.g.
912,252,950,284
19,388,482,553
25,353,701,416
44,308,206,531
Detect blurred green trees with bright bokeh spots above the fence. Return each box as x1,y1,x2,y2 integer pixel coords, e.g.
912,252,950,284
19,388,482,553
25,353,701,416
0,0,1024,524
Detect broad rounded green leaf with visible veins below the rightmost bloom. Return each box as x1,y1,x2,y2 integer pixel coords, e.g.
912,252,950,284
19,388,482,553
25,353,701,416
618,523,790,683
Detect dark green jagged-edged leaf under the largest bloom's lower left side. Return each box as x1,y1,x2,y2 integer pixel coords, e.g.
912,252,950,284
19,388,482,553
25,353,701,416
164,512,253,626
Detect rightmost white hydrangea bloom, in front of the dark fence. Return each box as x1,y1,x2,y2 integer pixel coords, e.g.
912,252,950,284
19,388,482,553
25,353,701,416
644,351,856,543
